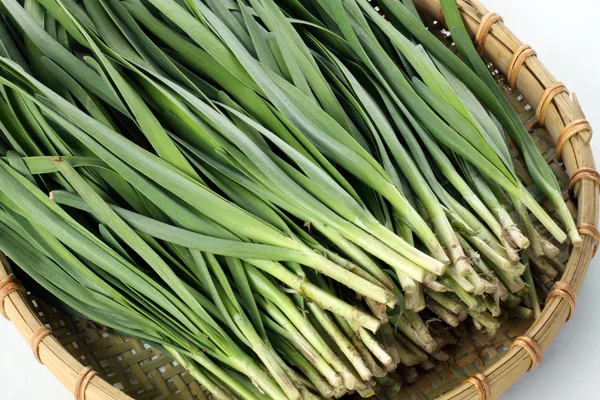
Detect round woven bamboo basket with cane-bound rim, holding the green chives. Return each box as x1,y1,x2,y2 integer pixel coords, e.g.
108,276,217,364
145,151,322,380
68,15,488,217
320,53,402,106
0,0,600,400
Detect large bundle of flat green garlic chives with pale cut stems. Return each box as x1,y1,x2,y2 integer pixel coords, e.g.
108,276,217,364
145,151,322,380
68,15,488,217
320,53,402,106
0,0,581,399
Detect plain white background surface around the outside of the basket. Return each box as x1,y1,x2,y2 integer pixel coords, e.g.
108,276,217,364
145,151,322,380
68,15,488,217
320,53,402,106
0,0,600,400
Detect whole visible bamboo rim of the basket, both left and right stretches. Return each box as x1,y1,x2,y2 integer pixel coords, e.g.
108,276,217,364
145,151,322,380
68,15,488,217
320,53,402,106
0,0,600,400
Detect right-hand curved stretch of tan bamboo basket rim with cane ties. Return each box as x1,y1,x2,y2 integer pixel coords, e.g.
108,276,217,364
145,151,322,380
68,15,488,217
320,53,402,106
415,0,600,400
